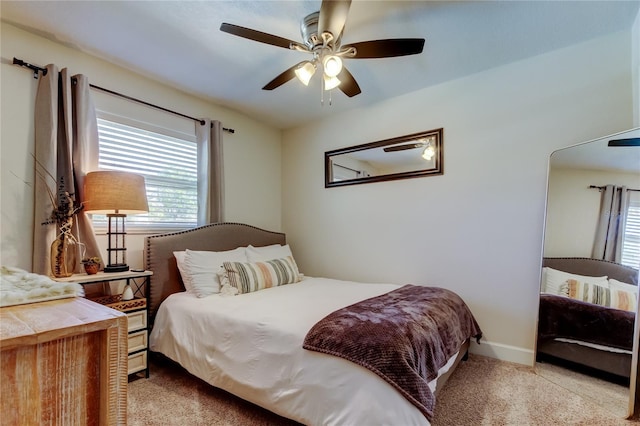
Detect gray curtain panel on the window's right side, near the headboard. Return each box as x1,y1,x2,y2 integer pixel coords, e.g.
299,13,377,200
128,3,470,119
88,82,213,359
195,119,224,226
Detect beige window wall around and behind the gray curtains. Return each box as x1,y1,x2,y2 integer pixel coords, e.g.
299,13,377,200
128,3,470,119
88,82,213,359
0,23,281,269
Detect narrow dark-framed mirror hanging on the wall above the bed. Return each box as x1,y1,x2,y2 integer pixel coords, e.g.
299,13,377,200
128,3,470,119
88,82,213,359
324,129,443,188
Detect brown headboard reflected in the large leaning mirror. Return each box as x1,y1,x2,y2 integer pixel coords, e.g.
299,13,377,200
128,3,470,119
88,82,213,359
542,257,638,285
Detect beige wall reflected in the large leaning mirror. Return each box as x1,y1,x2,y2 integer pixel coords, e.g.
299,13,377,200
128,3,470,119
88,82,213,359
544,164,640,257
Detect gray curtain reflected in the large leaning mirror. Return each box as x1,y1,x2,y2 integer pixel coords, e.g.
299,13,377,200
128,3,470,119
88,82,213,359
591,185,629,263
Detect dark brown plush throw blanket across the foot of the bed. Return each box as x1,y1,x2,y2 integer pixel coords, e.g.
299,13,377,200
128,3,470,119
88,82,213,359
303,284,482,420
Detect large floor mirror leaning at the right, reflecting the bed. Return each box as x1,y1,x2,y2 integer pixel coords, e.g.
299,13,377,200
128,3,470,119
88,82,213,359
536,129,640,418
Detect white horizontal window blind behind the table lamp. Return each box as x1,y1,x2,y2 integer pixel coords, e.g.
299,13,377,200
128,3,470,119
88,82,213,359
93,118,198,231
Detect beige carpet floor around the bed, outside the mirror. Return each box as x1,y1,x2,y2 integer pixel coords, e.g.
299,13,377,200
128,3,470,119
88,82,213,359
128,354,636,426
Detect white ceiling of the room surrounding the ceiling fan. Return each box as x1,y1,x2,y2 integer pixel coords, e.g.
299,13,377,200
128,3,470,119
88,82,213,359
0,0,640,128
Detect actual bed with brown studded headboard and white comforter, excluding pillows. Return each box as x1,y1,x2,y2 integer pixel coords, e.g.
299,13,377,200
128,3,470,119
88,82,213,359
145,223,481,425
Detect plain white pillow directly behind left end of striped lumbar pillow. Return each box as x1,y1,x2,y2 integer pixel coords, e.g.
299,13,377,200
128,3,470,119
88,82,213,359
183,247,248,297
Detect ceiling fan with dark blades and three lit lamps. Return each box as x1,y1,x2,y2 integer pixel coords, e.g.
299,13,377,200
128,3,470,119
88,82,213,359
220,0,424,97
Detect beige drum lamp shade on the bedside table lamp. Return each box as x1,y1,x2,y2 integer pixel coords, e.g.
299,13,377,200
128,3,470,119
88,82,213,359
83,171,149,214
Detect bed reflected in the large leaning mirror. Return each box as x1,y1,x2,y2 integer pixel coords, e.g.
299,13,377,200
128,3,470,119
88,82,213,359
537,257,638,379
